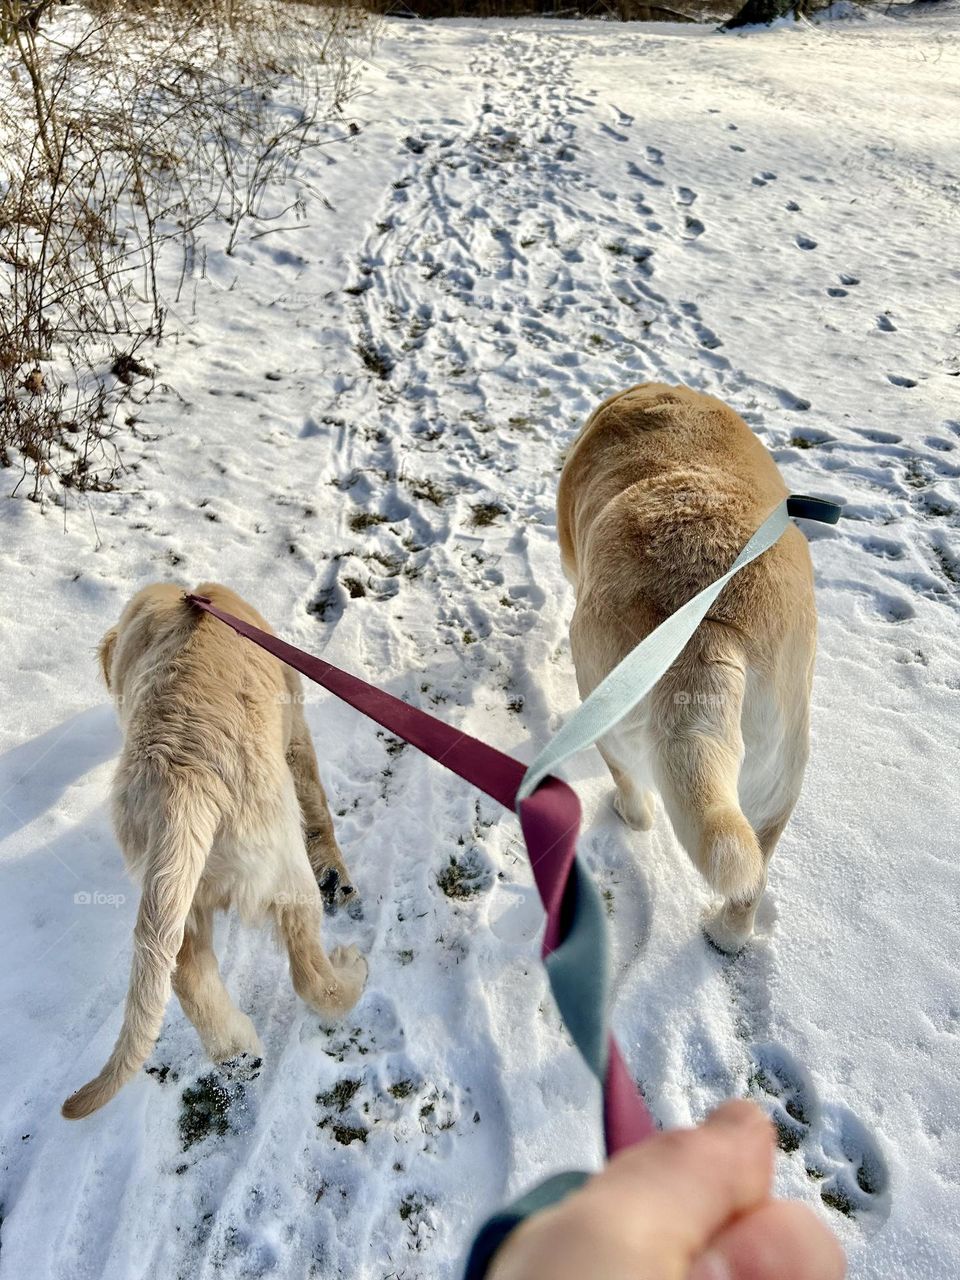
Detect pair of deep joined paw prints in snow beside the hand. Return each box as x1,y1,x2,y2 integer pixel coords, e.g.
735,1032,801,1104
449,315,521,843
750,1044,890,1222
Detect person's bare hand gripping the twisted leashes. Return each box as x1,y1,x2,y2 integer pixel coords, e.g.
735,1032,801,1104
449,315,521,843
489,1102,846,1280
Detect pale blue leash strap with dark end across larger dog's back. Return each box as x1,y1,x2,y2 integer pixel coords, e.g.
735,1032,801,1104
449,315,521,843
517,494,840,810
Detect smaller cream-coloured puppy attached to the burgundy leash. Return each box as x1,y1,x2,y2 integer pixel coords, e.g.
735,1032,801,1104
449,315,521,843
63,582,366,1120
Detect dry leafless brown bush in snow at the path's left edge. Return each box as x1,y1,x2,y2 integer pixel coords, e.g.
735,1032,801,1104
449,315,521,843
0,0,369,499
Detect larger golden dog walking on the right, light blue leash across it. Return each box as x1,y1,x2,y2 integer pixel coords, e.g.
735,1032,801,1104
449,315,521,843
557,383,817,951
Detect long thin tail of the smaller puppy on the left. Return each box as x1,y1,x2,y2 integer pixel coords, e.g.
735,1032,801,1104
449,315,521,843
60,788,218,1120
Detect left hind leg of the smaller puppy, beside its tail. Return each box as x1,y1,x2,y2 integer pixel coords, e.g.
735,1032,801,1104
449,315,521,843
173,904,262,1062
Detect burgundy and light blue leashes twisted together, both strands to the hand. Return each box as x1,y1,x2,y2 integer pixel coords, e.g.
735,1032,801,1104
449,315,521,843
186,494,841,1280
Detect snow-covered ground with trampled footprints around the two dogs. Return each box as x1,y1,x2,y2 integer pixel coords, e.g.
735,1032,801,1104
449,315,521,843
0,4,960,1280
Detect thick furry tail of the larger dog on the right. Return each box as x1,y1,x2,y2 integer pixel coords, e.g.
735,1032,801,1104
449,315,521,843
650,621,765,901
